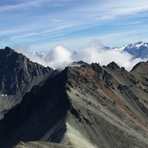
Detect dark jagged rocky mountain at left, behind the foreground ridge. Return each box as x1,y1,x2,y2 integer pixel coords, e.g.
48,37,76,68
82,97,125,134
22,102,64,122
0,47,53,118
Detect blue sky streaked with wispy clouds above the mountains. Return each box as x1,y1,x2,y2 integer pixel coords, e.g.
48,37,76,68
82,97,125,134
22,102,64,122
0,0,148,51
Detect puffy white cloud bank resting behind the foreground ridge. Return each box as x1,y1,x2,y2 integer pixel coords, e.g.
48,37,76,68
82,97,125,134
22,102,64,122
13,40,147,71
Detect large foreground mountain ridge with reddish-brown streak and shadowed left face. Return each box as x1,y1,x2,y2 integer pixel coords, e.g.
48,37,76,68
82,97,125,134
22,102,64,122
0,62,148,148
